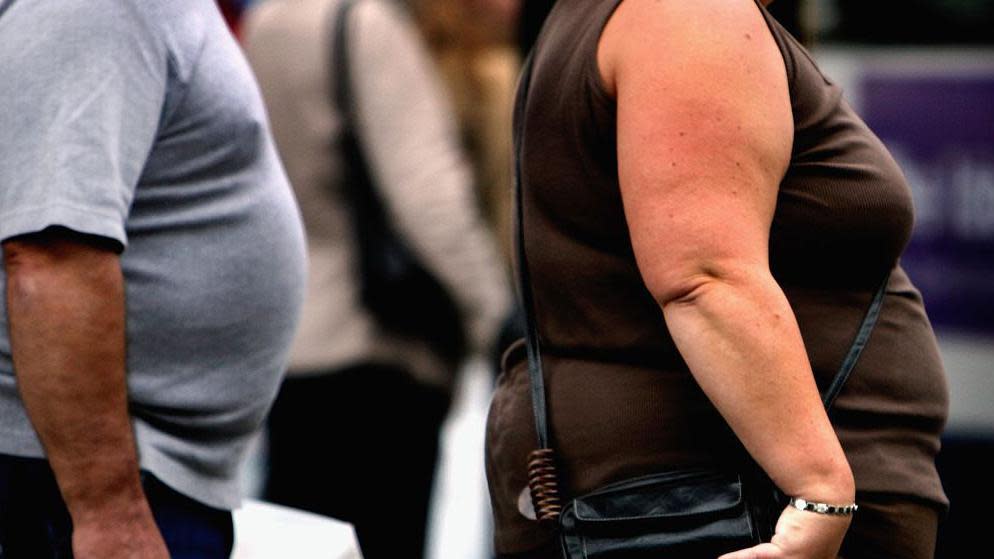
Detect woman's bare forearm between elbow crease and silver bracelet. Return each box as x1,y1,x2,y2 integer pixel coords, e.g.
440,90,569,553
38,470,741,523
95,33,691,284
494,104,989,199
662,270,854,503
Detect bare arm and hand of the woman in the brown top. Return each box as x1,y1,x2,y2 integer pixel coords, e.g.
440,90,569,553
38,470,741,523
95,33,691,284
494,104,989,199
598,0,854,559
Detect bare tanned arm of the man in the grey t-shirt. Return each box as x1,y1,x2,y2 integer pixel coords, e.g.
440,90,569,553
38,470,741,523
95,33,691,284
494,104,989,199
3,228,169,559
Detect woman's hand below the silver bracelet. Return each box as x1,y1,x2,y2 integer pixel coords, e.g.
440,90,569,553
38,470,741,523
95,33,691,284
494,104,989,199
718,507,852,559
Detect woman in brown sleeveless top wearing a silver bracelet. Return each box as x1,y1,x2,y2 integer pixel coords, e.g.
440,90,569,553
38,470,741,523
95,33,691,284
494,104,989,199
487,0,948,559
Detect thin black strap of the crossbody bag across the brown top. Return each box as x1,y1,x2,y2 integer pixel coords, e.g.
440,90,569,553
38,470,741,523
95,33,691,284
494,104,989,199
514,53,890,456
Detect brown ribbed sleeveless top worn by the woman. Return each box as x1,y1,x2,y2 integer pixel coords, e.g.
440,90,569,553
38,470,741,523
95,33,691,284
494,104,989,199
487,0,948,553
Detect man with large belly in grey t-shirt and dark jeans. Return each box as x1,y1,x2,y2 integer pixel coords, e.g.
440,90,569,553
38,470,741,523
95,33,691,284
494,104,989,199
0,0,304,559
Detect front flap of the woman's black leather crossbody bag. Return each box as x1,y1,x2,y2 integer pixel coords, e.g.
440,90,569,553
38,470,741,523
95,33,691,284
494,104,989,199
571,471,743,523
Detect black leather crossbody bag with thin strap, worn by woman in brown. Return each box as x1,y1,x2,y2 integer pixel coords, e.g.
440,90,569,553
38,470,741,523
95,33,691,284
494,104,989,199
514,51,890,559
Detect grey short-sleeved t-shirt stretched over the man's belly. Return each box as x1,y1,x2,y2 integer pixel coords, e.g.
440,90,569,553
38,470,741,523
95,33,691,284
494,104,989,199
0,0,305,508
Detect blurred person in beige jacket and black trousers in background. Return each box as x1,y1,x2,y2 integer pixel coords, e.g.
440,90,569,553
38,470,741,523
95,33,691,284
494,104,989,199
237,0,510,559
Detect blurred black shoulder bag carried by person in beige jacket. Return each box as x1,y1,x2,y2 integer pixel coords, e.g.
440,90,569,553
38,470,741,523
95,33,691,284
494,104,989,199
332,0,467,371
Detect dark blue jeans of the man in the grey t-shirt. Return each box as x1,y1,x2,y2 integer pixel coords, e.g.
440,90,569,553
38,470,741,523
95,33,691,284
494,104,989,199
0,454,234,559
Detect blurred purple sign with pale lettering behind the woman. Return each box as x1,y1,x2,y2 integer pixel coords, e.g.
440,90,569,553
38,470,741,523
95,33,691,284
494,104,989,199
861,73,994,333
